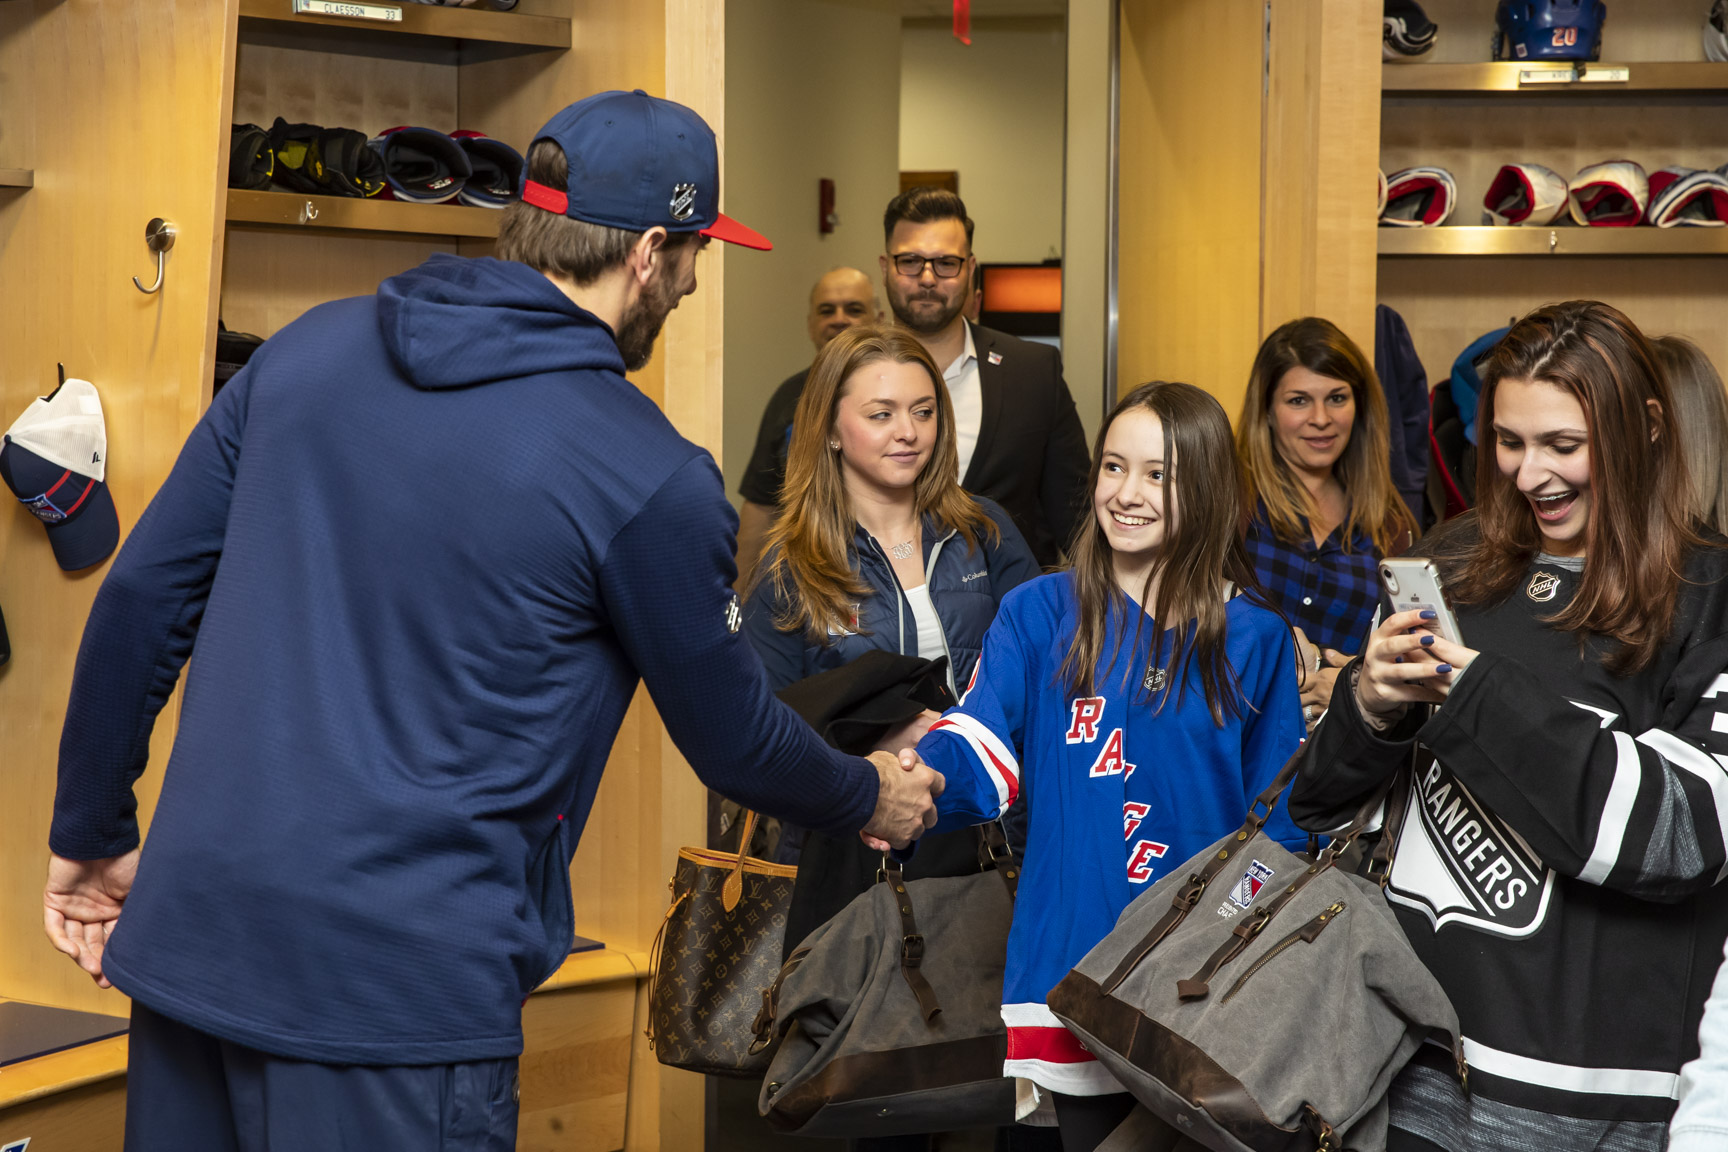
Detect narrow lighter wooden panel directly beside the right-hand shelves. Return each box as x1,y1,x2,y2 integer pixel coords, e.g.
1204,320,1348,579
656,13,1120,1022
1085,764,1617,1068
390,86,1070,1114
1257,0,1381,355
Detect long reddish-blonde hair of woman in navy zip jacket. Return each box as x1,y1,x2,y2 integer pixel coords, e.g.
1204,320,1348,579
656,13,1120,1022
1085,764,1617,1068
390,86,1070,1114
750,325,1001,642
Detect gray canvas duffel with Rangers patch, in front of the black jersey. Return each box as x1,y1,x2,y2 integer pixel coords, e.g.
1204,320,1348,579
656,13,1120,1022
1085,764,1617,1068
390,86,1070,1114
1049,751,1465,1152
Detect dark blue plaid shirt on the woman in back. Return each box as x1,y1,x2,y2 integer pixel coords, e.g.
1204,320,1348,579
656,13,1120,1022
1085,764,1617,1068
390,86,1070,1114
1248,503,1381,655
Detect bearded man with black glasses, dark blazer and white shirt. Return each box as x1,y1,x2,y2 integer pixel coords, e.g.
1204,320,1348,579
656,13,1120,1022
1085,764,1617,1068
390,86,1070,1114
881,188,1089,567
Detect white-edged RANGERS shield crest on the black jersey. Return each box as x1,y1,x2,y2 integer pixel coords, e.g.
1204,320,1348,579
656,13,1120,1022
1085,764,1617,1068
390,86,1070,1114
1386,762,1553,938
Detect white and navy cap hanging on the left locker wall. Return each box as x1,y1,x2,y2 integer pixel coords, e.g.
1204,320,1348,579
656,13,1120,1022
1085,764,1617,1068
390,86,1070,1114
0,380,119,572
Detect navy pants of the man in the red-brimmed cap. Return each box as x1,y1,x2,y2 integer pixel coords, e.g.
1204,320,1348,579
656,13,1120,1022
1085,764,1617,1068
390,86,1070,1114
126,1000,517,1152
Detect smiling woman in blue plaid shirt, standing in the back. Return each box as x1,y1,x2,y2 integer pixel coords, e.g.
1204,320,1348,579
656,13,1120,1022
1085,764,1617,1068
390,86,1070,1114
1236,316,1417,731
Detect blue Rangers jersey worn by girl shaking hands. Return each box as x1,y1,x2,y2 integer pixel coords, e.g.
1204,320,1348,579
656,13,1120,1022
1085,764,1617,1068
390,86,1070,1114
918,572,1306,1095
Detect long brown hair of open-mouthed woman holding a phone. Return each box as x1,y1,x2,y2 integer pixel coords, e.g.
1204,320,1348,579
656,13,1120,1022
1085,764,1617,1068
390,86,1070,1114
1436,301,1704,675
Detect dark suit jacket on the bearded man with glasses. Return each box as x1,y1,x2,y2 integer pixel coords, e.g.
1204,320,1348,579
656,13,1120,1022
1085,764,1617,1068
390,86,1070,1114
961,325,1092,567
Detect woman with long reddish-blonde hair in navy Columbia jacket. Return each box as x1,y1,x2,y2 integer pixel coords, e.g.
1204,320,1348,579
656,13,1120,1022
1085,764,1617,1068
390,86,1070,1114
745,328,1039,1152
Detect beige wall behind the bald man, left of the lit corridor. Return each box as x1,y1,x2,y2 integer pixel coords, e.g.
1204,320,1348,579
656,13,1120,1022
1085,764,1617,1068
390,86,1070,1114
721,0,900,503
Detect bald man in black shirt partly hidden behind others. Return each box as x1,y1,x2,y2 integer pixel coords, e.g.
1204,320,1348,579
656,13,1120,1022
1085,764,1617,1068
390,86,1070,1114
738,268,881,584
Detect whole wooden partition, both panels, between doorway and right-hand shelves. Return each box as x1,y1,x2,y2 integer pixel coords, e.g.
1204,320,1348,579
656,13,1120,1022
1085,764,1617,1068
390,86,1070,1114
1118,0,1381,418
